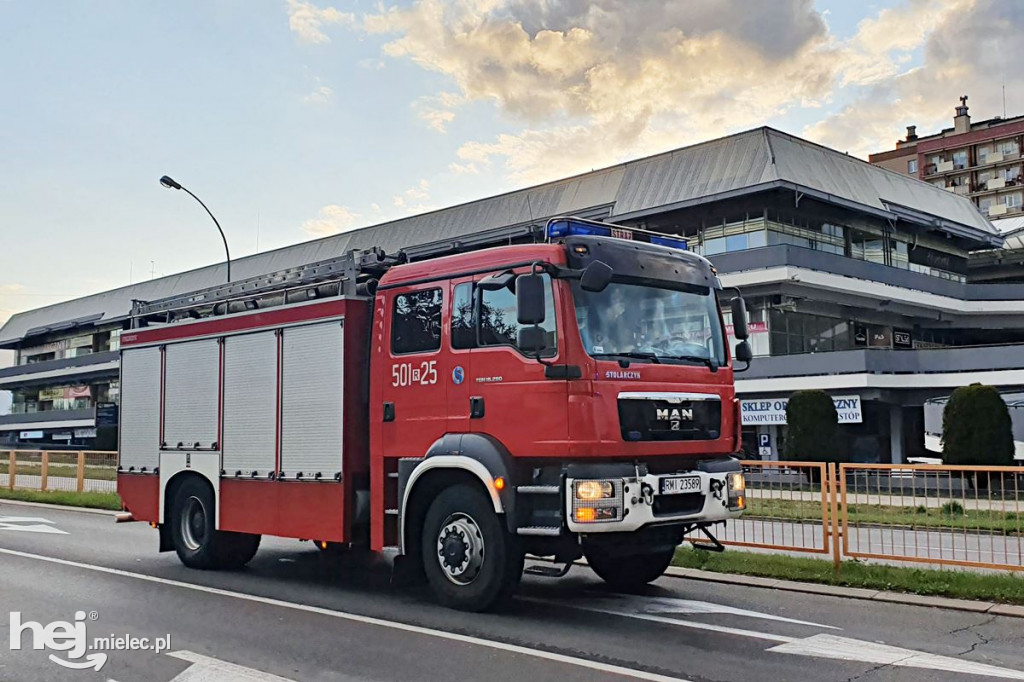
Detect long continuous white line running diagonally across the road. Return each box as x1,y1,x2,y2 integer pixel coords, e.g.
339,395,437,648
0,548,687,682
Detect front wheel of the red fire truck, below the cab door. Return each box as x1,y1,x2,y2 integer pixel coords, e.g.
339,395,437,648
420,483,523,611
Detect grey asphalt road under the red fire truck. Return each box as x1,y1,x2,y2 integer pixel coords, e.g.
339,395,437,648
0,503,1024,682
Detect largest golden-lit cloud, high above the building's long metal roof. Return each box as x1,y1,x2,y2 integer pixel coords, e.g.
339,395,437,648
360,0,840,182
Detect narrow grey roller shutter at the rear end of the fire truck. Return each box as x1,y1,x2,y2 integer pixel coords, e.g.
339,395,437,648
120,348,160,471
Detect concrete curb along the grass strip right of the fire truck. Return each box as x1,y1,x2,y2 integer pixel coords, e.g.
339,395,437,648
665,566,1024,619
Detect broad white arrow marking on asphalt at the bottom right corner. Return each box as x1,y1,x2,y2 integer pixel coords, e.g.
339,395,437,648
768,635,1024,680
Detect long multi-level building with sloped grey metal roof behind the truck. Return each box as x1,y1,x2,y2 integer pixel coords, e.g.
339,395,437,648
0,128,1024,460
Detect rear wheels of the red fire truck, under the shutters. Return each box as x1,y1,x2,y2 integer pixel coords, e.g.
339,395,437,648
167,477,260,570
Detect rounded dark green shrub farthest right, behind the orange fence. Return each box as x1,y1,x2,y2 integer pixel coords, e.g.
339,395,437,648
942,384,1014,466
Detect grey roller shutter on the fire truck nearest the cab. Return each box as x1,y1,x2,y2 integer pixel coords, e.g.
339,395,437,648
281,321,344,480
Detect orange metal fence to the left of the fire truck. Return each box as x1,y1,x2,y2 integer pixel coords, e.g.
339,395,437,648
0,450,118,493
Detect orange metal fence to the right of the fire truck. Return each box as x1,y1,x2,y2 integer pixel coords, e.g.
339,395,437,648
693,461,1024,570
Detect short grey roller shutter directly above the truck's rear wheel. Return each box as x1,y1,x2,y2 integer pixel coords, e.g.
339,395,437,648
164,339,220,449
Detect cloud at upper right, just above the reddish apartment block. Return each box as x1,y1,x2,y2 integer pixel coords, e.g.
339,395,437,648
803,0,1024,157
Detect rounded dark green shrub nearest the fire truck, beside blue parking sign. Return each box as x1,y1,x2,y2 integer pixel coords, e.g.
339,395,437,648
785,390,840,462
